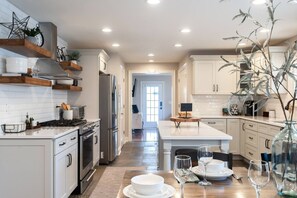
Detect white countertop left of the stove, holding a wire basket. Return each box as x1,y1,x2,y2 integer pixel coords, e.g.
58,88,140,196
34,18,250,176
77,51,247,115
0,127,79,139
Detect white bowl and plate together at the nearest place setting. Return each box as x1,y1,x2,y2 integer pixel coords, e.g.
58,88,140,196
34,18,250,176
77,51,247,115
123,174,175,198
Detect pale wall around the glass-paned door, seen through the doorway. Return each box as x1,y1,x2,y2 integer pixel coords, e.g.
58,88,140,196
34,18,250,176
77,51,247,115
132,75,172,120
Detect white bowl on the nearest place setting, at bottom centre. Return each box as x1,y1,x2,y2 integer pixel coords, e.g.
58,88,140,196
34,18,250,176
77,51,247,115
131,174,164,195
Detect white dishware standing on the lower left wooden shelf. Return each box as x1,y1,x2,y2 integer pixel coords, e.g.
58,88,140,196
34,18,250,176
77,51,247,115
6,57,28,73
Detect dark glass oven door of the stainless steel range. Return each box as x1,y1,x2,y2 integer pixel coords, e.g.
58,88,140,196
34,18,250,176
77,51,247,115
79,130,95,180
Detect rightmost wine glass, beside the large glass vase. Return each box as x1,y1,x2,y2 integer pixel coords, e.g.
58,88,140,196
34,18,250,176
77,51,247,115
248,160,270,198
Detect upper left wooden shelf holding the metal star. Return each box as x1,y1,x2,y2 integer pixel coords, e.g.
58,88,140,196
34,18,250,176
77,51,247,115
0,39,52,58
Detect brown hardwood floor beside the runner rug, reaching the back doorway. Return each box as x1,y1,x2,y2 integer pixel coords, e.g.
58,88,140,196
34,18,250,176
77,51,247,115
70,128,247,198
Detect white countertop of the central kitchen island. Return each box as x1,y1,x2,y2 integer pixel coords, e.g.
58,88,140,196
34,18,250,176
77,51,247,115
158,121,232,140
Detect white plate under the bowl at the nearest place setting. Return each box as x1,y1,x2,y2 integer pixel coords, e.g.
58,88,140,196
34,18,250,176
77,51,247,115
123,184,175,198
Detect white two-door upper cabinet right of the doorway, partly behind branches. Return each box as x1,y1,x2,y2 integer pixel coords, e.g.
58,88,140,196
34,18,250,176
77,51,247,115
191,55,238,94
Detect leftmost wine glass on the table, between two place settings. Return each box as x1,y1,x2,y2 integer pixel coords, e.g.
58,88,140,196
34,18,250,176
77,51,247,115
173,155,192,198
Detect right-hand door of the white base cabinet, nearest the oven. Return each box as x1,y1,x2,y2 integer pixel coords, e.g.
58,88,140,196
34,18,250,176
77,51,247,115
66,144,78,197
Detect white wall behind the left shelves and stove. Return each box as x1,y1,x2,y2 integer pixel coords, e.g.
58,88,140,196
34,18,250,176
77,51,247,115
0,0,67,132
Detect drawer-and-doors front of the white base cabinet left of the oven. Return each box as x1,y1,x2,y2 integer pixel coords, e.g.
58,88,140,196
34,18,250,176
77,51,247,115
54,132,78,198
